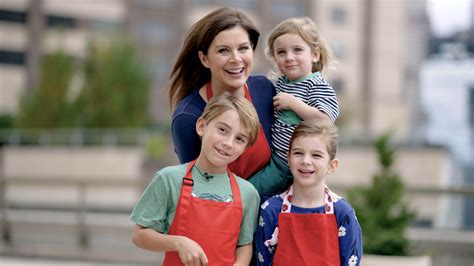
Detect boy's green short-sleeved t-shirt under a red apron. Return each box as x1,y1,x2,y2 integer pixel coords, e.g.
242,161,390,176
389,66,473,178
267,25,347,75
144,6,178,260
130,164,260,246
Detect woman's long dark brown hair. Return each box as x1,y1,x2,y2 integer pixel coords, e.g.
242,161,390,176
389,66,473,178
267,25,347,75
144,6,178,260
169,7,260,108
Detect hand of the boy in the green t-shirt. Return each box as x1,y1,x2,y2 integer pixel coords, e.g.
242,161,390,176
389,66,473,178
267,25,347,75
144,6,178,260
177,236,208,266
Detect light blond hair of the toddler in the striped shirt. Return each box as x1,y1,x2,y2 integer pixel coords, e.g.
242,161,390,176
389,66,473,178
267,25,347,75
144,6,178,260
265,17,333,72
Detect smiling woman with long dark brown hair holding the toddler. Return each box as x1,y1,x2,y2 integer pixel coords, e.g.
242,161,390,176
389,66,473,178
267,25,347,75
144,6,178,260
169,7,275,181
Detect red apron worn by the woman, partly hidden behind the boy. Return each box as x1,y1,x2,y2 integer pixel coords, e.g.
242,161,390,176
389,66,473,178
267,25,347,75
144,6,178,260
206,82,271,179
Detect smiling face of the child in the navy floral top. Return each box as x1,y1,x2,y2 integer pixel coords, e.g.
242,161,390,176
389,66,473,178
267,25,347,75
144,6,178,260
288,135,339,187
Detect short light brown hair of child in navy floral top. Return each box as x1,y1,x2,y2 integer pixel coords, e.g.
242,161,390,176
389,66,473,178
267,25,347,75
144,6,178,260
289,121,338,160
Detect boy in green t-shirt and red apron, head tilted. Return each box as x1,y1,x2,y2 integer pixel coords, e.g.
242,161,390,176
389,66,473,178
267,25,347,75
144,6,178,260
131,93,259,266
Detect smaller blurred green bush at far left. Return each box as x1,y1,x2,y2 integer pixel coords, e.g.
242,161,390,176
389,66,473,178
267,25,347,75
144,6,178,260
14,51,74,128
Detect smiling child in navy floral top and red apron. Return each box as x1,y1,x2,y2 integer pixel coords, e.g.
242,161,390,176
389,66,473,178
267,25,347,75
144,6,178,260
255,121,362,266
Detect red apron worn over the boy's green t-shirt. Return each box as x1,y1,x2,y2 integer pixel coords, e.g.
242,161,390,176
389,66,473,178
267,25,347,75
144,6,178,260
163,161,242,266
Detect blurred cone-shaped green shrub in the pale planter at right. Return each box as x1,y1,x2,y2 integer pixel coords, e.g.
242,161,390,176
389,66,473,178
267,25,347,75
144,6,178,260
348,134,414,255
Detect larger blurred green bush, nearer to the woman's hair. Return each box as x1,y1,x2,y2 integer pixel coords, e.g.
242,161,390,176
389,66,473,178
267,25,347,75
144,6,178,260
75,38,150,127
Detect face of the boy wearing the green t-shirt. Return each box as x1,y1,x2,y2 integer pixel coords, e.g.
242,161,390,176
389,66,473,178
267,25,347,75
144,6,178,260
196,109,249,173
